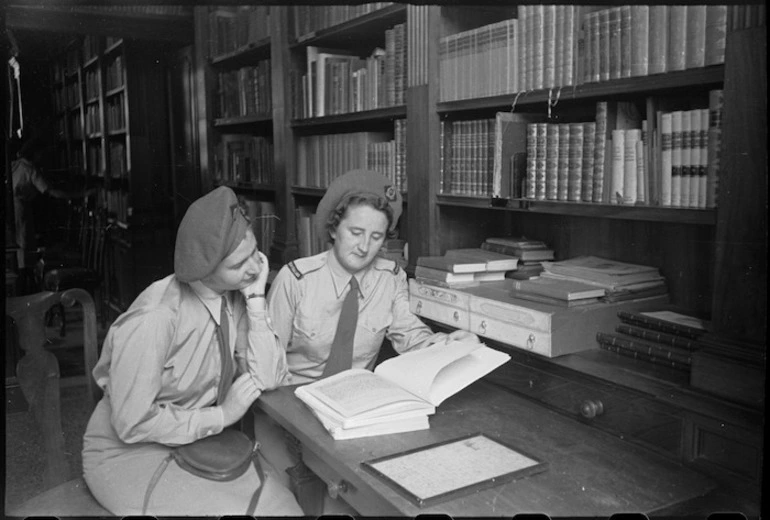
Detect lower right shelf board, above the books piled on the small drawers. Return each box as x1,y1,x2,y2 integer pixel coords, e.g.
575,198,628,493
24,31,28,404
437,195,716,226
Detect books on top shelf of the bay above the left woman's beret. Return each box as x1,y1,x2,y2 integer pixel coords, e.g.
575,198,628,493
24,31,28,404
208,5,270,58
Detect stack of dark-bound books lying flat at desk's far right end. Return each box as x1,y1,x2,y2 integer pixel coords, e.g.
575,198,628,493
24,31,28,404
596,311,708,372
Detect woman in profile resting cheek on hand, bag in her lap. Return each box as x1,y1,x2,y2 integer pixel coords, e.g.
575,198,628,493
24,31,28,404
83,187,302,516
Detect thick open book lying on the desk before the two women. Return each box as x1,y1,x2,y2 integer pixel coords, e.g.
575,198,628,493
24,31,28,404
295,341,510,439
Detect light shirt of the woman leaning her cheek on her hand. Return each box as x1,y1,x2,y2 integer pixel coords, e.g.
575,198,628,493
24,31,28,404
93,275,288,445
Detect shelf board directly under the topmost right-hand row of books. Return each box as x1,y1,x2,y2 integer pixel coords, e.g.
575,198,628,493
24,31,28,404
436,65,725,113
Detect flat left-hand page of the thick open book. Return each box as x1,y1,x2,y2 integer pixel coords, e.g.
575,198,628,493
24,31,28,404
304,369,427,417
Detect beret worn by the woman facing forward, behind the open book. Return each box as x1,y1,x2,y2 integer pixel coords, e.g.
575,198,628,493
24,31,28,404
315,170,403,241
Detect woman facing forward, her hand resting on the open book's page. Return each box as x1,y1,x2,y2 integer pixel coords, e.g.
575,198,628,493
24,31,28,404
256,170,478,513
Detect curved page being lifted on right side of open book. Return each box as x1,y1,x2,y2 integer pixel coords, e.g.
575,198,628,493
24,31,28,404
374,341,481,406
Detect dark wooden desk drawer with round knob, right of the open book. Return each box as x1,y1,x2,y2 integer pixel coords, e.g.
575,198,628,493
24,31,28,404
488,360,684,458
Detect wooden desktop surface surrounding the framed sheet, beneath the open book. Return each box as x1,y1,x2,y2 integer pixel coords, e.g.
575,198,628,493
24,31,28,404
257,381,715,517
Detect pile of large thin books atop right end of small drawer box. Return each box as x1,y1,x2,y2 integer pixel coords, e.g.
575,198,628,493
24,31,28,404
540,256,668,302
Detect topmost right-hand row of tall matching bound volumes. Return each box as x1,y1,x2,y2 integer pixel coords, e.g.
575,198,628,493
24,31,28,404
439,5,727,101
